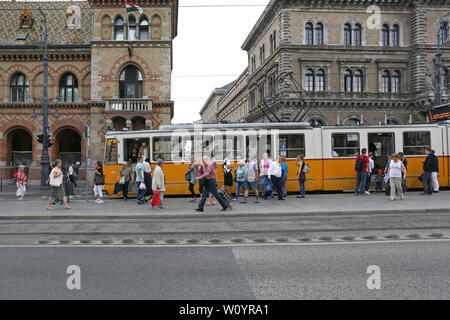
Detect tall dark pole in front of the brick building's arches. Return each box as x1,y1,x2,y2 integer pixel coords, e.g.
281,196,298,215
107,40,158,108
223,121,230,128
39,8,50,189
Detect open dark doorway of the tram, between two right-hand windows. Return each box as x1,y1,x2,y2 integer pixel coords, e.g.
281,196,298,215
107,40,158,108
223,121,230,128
368,133,395,170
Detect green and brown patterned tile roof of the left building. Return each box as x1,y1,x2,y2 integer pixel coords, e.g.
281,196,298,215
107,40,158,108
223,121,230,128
0,1,93,47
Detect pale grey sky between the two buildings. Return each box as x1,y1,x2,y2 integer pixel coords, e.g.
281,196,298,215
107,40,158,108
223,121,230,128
172,0,269,123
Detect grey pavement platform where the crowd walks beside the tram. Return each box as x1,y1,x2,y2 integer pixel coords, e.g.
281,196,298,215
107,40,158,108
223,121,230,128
0,191,450,220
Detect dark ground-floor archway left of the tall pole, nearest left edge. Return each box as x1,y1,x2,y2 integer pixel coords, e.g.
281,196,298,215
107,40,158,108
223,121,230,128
6,128,33,175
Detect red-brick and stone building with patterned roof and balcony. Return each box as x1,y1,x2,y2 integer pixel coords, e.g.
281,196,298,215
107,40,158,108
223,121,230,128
0,0,178,181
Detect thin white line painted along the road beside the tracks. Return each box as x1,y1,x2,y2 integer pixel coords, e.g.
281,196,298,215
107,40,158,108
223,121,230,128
0,239,450,248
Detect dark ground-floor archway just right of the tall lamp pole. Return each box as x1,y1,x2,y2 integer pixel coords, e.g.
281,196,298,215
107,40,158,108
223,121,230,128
56,128,81,168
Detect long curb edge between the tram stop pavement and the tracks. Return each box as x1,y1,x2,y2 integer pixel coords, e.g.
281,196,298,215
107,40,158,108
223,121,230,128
0,208,450,221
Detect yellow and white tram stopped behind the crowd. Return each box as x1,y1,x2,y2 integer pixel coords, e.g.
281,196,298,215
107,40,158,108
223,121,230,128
104,122,450,195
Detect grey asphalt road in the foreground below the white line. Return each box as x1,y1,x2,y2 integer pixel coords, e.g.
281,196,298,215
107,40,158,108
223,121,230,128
0,240,450,300
